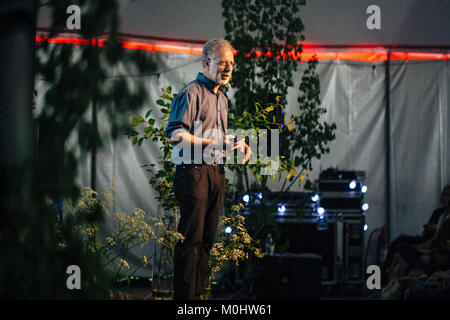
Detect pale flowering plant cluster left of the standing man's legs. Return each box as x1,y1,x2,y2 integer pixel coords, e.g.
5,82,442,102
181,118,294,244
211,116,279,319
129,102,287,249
60,184,184,284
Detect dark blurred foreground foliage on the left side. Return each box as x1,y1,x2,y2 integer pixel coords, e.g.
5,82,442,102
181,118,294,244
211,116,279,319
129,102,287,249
0,0,155,299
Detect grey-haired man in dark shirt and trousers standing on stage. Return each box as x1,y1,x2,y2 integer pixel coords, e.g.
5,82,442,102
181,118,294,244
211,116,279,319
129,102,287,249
166,39,251,300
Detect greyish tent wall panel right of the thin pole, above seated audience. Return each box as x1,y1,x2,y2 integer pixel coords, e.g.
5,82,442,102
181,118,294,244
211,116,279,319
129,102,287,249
391,61,450,239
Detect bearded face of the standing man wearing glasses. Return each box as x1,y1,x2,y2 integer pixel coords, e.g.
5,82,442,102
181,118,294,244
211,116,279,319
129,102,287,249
204,47,234,86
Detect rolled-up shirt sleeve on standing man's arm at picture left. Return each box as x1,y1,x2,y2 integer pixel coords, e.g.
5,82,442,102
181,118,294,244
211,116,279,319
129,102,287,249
166,89,195,138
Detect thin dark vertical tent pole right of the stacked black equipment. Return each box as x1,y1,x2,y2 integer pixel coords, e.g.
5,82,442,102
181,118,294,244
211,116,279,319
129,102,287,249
385,50,392,238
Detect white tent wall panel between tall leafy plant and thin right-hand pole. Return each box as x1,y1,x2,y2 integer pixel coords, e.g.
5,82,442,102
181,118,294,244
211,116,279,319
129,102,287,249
274,60,387,256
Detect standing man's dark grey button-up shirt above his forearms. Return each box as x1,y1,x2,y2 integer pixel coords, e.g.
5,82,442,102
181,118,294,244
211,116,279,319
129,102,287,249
166,73,228,139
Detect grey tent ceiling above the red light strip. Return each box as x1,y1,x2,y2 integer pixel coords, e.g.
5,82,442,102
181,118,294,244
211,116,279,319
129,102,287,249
37,0,450,51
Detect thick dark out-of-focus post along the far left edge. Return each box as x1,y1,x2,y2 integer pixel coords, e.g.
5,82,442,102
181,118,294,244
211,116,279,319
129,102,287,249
0,0,36,225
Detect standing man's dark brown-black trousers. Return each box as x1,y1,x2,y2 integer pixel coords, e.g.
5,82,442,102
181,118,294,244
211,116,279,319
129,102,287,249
174,164,225,300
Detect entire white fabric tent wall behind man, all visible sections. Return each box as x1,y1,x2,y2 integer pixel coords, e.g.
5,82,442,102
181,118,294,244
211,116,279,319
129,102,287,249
37,48,450,275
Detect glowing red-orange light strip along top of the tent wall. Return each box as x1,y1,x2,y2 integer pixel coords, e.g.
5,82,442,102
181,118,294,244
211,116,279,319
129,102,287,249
36,35,450,62
